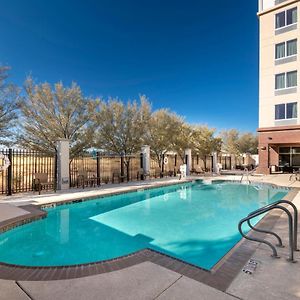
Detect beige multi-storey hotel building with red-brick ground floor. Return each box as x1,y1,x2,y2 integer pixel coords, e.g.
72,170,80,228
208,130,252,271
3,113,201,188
258,0,300,174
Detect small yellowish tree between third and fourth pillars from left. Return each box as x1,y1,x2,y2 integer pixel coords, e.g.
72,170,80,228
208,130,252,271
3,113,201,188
192,126,222,169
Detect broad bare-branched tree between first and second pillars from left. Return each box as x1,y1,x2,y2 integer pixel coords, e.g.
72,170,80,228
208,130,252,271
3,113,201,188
93,96,151,179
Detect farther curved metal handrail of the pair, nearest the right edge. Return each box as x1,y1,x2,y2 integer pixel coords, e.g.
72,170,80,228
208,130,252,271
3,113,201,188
248,199,299,251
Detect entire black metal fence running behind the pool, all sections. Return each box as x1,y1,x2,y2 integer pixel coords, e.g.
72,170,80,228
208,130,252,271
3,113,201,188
0,149,246,195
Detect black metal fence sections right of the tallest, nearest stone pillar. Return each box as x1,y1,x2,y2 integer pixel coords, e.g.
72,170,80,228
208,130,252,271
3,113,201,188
70,153,237,187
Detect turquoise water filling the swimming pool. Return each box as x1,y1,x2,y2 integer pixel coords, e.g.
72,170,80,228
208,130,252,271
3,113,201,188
0,182,288,269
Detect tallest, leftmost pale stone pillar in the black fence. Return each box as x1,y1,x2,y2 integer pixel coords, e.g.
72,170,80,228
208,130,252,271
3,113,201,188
56,139,70,190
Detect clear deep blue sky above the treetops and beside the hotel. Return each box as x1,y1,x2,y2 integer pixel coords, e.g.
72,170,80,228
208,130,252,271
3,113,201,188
0,0,258,131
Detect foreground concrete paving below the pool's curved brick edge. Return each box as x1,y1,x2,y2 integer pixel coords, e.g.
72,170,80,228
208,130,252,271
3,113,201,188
0,262,235,300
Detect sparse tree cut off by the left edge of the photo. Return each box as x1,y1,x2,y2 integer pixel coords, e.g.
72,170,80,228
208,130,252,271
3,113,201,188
0,66,19,145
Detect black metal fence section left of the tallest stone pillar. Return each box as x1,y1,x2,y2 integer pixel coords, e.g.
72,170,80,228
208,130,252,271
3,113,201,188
0,149,56,195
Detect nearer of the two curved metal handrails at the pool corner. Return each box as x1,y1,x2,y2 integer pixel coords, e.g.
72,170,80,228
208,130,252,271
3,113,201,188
238,204,295,262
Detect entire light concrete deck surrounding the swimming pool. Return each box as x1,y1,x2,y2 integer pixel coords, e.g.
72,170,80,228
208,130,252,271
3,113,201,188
0,174,300,300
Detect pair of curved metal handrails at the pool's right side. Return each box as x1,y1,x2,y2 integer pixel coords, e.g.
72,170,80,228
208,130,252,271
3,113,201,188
238,200,299,262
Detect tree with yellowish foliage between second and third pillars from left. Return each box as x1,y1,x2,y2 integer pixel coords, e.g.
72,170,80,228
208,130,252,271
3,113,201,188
146,109,183,168
